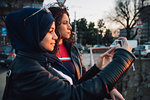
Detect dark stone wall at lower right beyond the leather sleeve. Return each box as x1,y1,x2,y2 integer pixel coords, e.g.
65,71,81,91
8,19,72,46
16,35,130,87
116,58,150,100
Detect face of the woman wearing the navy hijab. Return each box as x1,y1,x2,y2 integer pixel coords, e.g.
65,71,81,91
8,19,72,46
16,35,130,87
40,22,58,51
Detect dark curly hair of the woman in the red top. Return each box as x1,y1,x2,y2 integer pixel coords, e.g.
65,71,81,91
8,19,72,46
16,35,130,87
49,7,74,53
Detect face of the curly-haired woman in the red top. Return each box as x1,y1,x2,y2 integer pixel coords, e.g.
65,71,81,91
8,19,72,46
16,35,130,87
58,14,72,39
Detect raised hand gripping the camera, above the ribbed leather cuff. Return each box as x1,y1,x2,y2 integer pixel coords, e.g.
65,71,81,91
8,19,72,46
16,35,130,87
117,37,132,53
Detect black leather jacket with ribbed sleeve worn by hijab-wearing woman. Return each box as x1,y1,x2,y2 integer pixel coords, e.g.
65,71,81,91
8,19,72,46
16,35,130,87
2,49,135,100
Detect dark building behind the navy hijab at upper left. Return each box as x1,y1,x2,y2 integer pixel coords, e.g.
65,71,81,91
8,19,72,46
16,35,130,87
0,0,43,45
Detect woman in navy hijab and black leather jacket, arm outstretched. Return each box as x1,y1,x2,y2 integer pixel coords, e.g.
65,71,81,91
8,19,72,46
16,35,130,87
3,8,135,100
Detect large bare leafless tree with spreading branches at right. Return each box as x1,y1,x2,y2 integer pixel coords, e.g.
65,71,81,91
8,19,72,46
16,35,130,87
109,0,146,39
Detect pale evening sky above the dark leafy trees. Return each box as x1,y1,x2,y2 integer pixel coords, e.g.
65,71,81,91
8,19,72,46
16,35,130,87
45,0,119,28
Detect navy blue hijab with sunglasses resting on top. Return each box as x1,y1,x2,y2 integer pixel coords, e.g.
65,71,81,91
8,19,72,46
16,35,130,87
5,8,55,53
